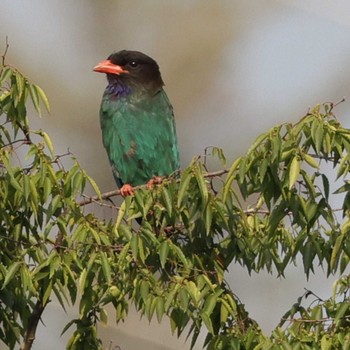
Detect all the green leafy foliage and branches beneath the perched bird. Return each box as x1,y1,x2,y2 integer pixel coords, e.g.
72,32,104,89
0,60,350,349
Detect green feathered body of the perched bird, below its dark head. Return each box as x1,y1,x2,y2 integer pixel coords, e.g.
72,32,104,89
100,90,179,187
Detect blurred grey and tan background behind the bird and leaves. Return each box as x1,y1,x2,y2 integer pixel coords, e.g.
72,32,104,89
0,0,350,350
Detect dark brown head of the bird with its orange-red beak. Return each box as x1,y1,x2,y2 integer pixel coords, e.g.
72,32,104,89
94,50,164,94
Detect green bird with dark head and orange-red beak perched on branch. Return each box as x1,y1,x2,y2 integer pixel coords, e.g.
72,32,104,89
94,50,179,196
